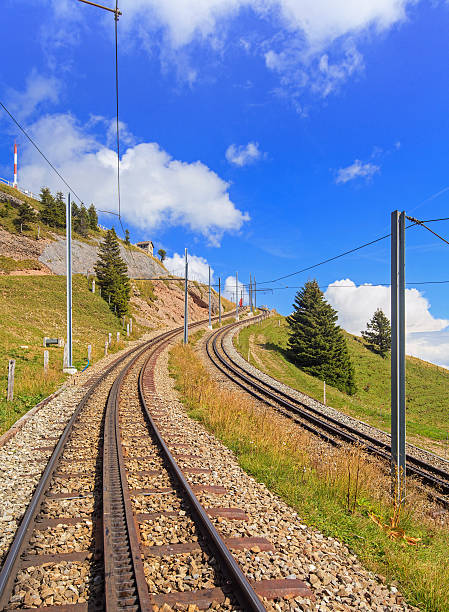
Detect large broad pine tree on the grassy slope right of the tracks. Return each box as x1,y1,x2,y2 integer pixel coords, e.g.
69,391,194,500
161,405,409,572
287,280,356,395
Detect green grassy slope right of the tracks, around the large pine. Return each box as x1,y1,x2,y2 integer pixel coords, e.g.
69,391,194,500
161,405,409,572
234,317,449,450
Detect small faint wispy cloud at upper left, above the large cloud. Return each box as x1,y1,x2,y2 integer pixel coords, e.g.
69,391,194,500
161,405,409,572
6,69,62,120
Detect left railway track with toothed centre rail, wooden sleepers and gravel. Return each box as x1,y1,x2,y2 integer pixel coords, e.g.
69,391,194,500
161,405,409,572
0,314,312,612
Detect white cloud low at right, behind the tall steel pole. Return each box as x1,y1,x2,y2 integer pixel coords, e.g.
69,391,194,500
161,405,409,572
325,279,449,367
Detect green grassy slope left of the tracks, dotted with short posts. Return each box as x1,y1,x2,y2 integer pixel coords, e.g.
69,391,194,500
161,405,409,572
0,275,140,433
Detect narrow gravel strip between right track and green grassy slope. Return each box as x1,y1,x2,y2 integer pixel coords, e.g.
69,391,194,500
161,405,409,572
223,321,449,472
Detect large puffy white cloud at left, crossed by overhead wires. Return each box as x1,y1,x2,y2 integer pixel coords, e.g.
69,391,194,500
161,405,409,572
21,115,249,245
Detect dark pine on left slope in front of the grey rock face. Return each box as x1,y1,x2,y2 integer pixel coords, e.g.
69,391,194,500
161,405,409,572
94,229,130,317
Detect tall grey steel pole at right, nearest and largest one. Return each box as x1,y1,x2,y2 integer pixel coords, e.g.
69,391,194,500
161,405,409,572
391,210,406,503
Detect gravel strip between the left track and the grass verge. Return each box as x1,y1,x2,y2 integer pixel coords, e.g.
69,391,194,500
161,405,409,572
154,342,416,612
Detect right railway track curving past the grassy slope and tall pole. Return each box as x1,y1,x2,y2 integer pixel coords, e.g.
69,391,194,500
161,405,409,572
206,314,449,507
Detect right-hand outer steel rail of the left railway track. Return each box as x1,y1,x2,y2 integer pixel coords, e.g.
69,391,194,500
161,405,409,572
139,343,266,612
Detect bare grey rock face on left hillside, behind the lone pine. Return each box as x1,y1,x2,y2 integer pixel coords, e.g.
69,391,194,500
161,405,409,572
39,236,167,278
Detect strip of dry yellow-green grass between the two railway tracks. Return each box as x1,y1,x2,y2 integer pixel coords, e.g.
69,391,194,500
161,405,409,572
170,345,449,612
